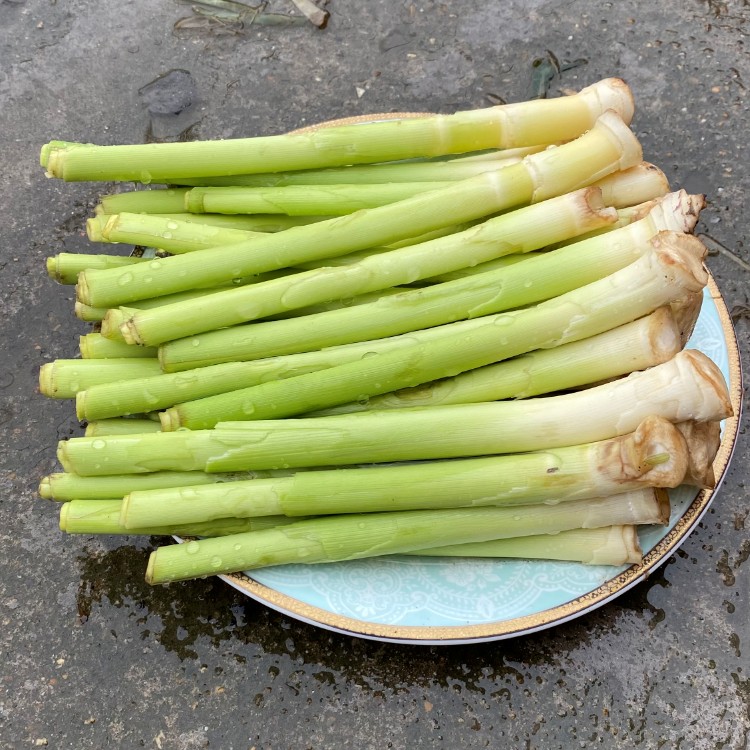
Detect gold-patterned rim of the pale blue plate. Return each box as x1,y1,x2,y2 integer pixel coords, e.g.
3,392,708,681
209,269,742,645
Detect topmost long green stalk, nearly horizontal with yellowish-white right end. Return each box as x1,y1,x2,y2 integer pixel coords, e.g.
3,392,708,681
45,79,633,183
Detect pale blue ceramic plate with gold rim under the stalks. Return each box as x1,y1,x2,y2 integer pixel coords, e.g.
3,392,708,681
203,279,741,644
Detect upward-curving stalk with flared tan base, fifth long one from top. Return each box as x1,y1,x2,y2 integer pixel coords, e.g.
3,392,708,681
159,232,707,430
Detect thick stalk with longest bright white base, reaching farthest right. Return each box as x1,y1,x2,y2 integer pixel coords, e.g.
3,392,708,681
58,349,732,476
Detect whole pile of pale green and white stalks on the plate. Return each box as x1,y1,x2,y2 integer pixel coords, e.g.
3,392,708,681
40,79,732,583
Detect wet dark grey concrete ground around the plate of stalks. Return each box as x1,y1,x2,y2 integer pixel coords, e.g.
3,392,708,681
0,0,750,750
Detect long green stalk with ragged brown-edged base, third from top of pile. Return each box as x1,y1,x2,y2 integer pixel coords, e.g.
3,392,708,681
123,182,616,348
